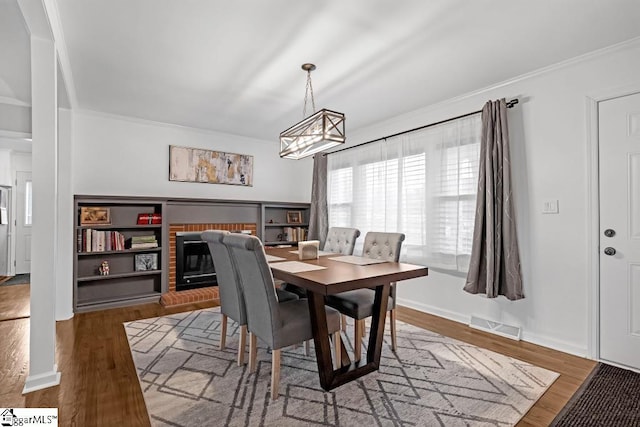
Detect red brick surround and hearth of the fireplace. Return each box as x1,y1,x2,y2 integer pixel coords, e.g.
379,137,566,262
160,223,257,307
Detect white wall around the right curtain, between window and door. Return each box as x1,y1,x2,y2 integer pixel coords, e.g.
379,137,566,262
349,40,640,355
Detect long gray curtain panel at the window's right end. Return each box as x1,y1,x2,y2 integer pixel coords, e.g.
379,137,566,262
464,99,524,300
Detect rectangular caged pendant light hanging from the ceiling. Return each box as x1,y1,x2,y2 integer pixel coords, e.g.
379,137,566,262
280,64,346,160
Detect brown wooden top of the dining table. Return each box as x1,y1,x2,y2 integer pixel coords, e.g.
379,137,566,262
265,247,428,295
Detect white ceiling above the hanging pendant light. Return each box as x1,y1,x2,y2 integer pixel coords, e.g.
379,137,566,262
0,0,640,140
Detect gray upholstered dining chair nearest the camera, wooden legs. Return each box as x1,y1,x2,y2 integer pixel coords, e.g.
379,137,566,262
222,234,341,400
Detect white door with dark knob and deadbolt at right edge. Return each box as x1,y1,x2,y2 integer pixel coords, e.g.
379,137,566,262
598,93,640,369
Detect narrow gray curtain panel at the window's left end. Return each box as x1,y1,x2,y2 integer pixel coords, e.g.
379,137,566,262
309,153,329,248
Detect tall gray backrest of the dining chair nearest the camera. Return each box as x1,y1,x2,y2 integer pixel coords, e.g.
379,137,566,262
222,233,281,346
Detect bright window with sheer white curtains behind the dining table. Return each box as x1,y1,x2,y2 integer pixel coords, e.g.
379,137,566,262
327,114,481,272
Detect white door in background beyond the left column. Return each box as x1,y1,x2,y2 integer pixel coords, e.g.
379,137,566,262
16,172,33,274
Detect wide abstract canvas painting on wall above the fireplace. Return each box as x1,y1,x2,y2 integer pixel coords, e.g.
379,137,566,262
169,145,253,187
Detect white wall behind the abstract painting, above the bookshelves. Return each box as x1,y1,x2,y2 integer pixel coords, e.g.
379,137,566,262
72,110,313,202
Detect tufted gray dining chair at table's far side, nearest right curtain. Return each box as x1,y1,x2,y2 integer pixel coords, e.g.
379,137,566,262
326,231,404,360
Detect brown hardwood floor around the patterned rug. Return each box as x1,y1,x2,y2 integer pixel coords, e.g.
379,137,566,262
0,303,595,426
